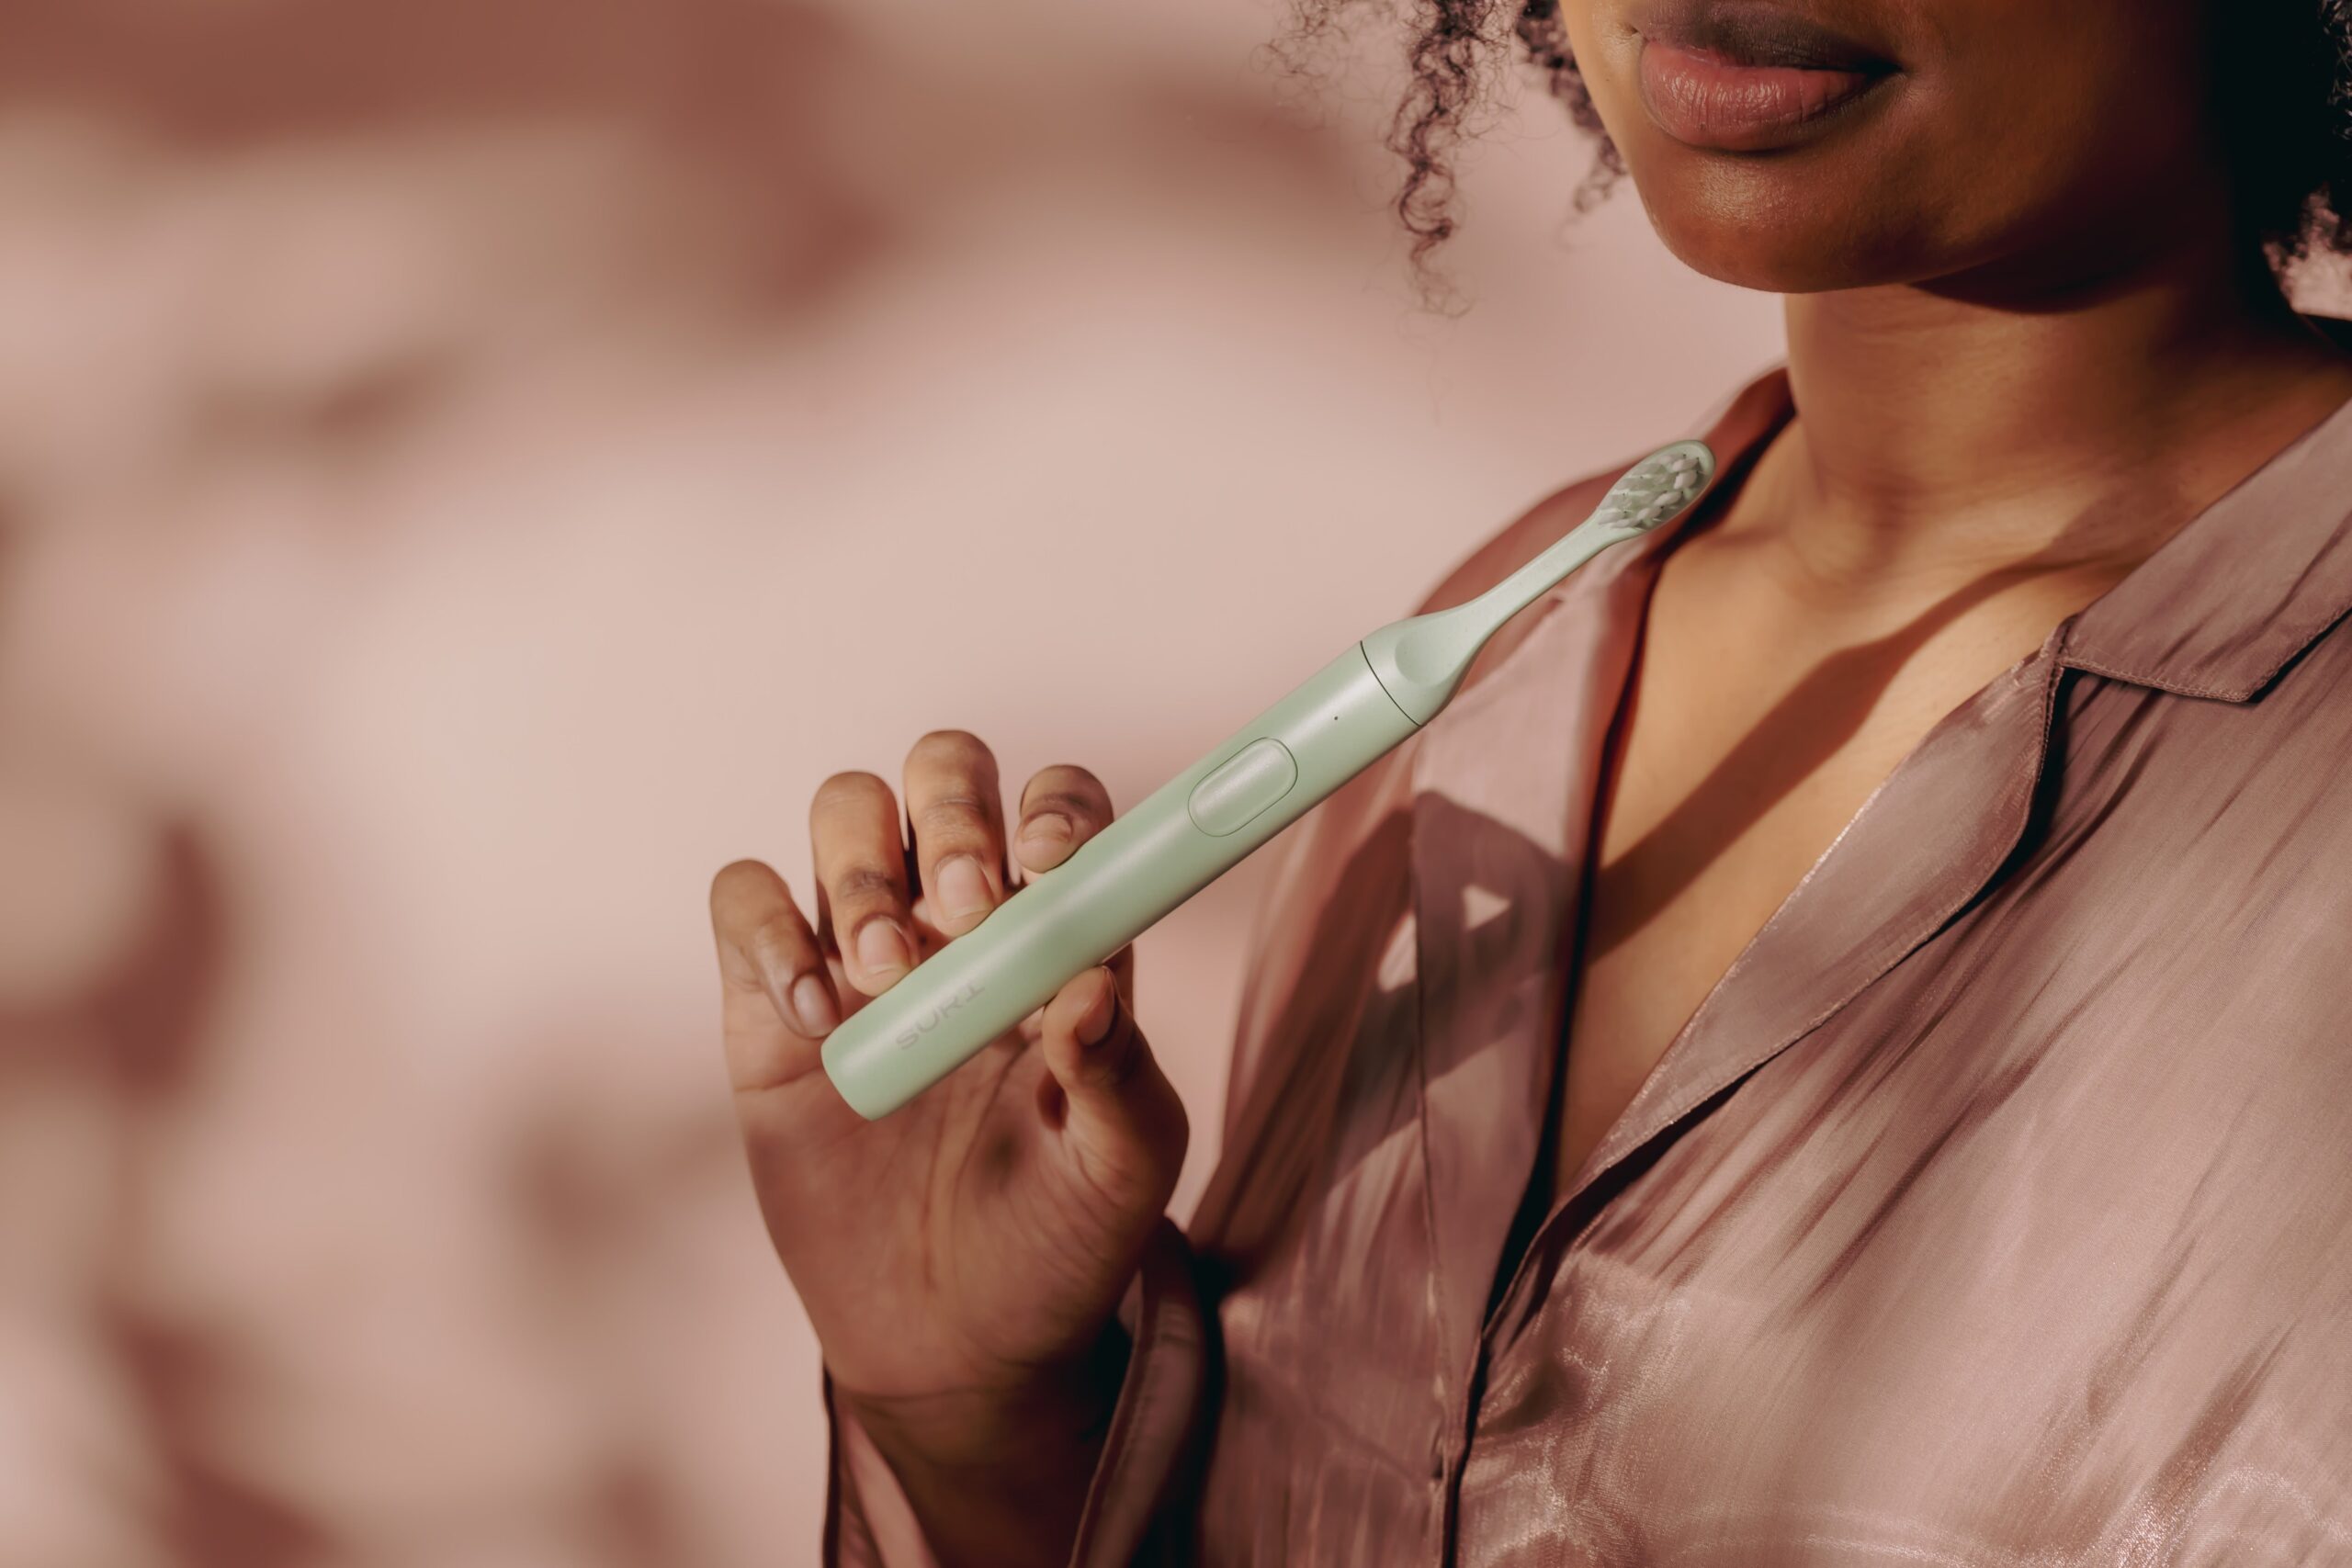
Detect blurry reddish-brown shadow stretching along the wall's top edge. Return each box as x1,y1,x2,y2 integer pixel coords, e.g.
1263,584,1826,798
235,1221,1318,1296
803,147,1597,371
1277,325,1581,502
0,0,1362,338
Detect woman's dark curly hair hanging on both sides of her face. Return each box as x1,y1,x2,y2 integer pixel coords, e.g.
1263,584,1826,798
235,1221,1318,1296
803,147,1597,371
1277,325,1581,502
1275,0,2352,312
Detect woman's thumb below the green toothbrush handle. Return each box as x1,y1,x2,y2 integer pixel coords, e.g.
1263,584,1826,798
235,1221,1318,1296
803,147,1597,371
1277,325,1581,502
1037,966,1193,1213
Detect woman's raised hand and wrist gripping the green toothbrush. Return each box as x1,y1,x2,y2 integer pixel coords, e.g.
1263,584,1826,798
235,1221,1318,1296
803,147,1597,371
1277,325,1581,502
710,731,1188,1565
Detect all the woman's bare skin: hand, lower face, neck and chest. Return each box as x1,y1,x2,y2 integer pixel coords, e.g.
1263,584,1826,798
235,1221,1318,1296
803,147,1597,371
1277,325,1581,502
713,0,2352,1563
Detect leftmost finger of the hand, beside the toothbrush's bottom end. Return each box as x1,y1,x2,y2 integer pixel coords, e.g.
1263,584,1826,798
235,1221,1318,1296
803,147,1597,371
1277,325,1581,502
710,861,840,1089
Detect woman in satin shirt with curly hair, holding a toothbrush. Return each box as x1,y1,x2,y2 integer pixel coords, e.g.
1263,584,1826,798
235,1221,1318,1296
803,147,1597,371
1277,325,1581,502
713,0,2352,1568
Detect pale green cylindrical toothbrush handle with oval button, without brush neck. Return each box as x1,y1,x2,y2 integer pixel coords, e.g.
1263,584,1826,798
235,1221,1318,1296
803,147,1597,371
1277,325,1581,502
823,642,1419,1119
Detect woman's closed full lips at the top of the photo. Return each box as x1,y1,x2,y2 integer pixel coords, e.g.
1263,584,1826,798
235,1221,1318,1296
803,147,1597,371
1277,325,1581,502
1637,0,1900,152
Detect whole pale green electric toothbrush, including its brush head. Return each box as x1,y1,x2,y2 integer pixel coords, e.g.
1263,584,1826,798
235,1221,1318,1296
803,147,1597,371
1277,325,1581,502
823,442,1714,1119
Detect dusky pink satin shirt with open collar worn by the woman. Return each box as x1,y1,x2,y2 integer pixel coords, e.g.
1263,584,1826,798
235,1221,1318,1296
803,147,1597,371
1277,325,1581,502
826,338,2352,1568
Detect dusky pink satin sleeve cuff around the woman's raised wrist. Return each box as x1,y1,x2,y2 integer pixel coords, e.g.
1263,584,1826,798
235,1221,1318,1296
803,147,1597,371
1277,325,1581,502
823,1215,1211,1568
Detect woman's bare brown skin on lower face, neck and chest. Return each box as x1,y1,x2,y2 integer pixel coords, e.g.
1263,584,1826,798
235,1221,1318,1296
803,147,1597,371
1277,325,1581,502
1550,0,2352,1194
